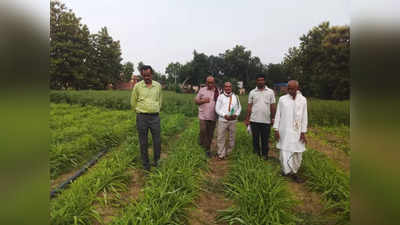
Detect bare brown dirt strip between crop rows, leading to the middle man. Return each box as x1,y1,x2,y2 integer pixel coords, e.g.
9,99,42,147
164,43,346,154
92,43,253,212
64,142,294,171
189,139,233,225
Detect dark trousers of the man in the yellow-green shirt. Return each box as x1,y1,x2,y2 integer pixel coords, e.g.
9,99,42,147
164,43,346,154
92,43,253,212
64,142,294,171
136,113,161,170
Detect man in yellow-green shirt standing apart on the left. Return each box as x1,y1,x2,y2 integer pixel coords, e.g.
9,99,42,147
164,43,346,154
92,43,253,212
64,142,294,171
131,65,162,171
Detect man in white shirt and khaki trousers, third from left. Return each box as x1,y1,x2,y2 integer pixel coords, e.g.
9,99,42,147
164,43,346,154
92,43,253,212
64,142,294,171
215,82,242,160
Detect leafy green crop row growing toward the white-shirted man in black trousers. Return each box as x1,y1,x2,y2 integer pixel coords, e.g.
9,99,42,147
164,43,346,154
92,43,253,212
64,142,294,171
219,124,299,225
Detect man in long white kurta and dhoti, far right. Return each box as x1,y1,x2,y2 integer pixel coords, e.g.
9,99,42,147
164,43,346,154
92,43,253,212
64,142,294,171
273,80,308,180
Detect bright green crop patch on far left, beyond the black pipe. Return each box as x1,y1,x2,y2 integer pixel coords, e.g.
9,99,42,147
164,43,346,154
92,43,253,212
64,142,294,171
49,104,135,178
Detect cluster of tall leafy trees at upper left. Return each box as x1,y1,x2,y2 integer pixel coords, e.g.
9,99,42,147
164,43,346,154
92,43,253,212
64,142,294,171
50,0,122,90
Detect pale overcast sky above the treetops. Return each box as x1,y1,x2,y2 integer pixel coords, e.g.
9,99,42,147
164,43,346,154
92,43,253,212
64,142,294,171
57,0,351,73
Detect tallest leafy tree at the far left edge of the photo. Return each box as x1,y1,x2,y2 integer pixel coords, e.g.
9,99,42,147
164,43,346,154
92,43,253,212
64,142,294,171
49,1,91,89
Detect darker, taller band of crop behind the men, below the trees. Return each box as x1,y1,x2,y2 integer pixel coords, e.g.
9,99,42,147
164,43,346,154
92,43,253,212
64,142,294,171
50,91,350,126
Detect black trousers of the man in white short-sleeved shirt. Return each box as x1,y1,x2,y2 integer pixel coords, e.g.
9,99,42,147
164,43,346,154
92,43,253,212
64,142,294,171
250,122,271,158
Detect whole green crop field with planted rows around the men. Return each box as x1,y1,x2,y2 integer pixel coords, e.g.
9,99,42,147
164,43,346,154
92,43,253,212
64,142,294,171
49,91,351,225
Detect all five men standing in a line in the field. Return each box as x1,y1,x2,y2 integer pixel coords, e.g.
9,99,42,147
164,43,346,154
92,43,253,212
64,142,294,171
131,66,307,181
